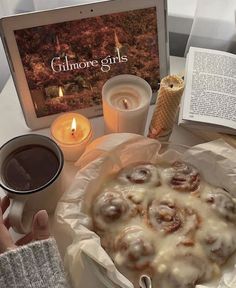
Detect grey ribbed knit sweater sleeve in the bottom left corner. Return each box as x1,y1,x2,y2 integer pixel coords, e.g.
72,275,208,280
0,238,69,288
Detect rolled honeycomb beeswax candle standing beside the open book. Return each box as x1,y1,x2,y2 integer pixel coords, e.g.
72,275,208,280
148,75,184,140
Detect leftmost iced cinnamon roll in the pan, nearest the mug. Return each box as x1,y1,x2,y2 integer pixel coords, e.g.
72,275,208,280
92,191,134,230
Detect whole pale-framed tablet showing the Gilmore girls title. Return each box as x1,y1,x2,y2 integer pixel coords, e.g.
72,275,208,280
0,0,169,129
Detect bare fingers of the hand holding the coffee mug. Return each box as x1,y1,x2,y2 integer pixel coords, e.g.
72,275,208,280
0,197,50,253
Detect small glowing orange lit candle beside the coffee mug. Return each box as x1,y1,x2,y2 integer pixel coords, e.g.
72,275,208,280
51,113,92,161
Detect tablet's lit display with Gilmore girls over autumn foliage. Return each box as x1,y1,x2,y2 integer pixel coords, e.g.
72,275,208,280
14,7,160,118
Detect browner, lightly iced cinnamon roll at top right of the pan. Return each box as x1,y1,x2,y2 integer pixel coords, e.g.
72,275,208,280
163,161,200,192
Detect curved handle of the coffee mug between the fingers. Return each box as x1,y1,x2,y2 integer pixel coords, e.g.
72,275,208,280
8,199,33,234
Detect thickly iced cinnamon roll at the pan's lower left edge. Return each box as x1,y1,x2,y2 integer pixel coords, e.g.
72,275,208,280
115,226,155,270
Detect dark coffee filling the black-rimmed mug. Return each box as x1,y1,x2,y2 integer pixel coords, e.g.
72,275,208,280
1,144,59,192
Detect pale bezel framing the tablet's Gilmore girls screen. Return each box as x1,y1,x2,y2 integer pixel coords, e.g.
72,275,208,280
0,0,169,130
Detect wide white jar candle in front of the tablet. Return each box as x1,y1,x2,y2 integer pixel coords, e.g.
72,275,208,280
102,74,152,135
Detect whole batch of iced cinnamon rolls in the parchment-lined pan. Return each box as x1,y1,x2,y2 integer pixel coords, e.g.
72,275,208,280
55,134,236,288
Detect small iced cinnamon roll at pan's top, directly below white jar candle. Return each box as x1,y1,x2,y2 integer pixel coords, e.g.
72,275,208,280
118,163,160,186
